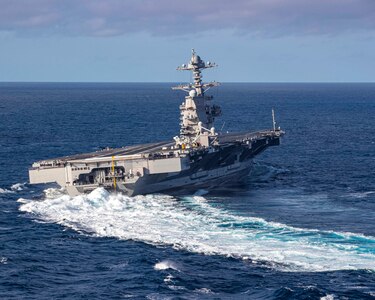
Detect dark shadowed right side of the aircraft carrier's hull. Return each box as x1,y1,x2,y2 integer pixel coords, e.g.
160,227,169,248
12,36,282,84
104,135,279,196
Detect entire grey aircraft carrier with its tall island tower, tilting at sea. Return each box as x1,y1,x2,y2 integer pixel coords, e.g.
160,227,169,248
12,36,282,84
29,50,284,196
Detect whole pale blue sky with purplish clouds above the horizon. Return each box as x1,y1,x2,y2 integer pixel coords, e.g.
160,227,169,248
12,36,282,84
0,0,375,82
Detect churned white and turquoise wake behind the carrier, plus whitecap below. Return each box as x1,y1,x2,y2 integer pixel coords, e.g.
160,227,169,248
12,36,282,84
20,188,375,271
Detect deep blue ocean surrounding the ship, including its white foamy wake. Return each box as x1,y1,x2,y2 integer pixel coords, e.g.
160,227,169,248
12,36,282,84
0,83,375,300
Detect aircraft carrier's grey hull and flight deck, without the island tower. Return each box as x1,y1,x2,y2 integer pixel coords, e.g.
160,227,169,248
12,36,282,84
29,130,280,196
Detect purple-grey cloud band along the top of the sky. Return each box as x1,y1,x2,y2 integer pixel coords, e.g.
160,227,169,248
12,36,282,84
0,0,375,36
